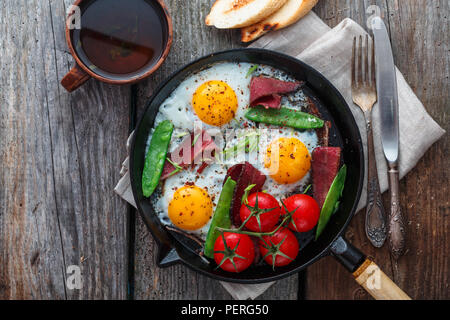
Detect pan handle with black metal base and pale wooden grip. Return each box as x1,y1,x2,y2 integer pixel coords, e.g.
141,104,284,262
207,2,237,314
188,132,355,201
330,237,411,300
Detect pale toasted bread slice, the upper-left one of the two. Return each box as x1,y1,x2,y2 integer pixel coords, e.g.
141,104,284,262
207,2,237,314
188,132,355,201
205,0,287,29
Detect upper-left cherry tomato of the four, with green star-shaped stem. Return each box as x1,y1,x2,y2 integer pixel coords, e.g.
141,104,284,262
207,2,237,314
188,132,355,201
239,192,281,232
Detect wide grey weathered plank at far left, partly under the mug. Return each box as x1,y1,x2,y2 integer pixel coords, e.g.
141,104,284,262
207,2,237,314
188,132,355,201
0,0,129,299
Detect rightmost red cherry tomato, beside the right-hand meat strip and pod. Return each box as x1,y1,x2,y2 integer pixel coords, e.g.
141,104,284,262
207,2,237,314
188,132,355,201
282,194,320,232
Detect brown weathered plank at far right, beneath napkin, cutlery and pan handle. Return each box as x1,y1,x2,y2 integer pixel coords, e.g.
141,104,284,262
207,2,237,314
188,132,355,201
307,0,450,299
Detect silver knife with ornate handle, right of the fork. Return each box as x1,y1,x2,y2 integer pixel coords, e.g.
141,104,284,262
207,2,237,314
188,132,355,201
372,17,406,259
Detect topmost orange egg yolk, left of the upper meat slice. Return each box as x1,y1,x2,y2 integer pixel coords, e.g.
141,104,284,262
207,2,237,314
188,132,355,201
192,80,238,127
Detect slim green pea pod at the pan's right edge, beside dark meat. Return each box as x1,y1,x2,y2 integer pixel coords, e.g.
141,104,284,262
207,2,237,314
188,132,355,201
316,165,347,240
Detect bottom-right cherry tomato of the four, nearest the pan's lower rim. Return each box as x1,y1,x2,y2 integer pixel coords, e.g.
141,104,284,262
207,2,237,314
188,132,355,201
259,228,299,268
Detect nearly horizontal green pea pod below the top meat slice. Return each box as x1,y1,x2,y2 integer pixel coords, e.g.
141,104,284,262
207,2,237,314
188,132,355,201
245,106,325,130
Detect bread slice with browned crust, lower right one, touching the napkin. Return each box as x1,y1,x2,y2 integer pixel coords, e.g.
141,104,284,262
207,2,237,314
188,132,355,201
241,0,319,42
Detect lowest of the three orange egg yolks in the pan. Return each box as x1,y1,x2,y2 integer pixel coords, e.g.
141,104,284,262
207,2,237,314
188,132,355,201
168,186,213,230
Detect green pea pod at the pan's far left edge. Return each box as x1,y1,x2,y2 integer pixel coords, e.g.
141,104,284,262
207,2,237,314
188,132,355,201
142,120,173,197
